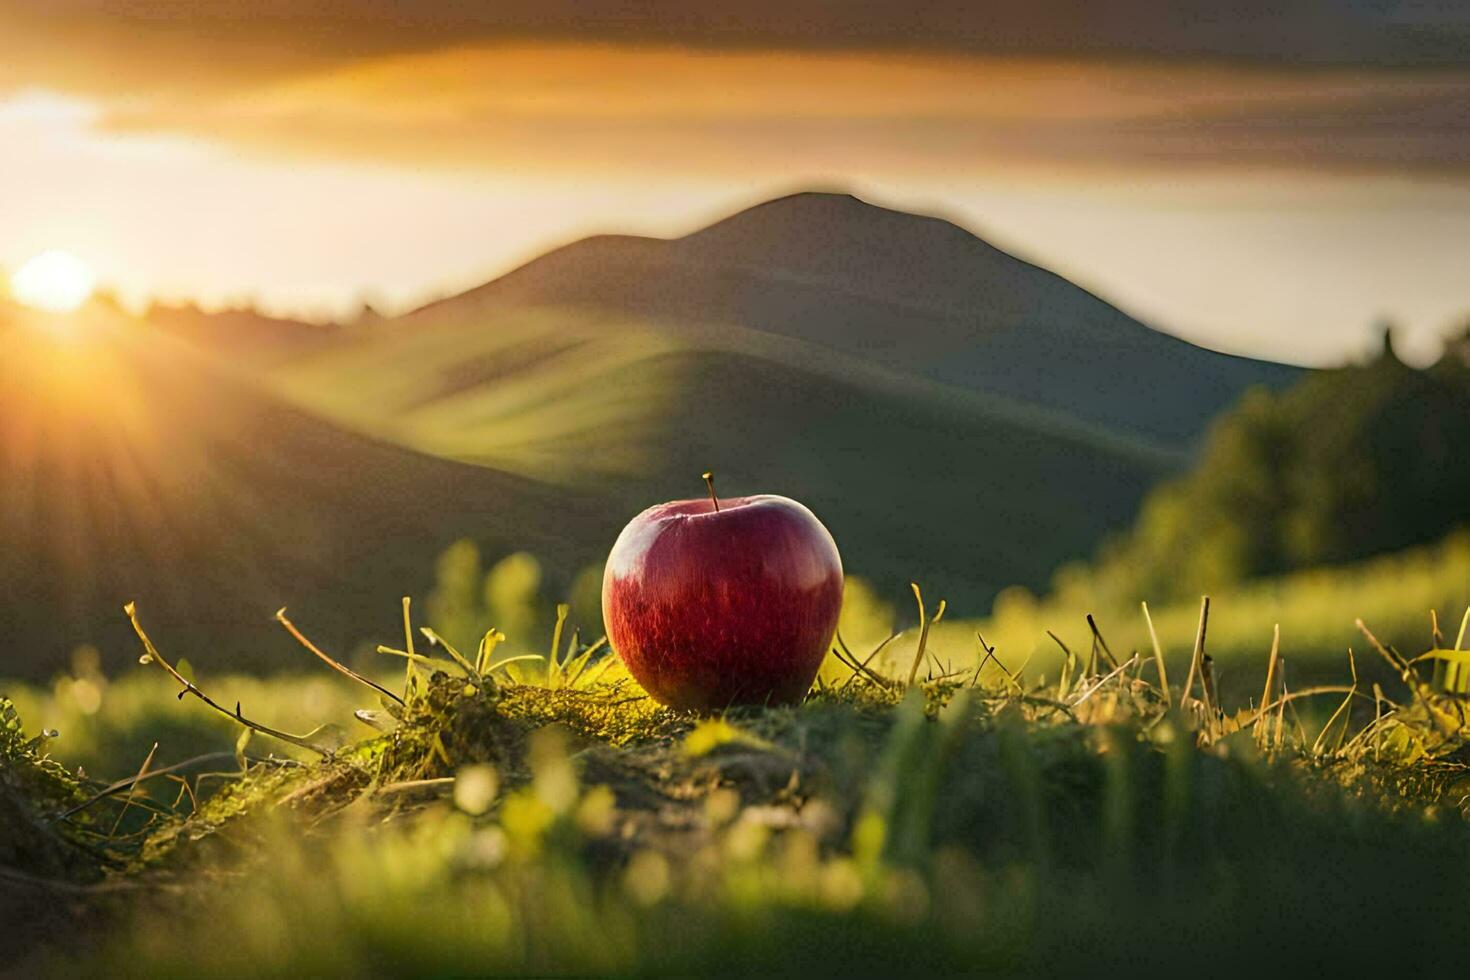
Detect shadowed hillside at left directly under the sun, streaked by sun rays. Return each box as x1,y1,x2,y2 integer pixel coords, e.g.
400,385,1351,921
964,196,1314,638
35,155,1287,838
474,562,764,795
0,307,614,676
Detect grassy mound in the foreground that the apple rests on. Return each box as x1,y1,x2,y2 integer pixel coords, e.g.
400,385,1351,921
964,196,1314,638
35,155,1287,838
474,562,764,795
0,590,1470,976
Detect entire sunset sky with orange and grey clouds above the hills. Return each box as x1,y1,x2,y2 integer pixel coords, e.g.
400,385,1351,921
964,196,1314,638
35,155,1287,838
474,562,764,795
0,0,1470,363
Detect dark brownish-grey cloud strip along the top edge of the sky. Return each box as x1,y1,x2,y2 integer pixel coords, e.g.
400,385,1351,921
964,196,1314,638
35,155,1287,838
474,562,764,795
0,0,1470,88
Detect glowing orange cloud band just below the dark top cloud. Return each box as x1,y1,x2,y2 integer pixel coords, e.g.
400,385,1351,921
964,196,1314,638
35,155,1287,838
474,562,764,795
91,43,1470,173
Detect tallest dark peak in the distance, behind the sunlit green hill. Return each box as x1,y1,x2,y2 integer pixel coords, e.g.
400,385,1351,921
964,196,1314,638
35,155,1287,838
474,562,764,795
423,192,1299,448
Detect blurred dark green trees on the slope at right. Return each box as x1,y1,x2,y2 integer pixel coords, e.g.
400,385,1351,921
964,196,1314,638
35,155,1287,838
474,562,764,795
1076,331,1470,602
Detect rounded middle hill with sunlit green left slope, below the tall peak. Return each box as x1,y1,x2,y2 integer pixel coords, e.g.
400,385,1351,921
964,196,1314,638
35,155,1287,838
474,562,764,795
275,307,1180,608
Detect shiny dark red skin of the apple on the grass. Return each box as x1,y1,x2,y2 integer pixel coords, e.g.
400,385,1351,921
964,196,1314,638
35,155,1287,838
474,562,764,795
603,494,842,711
